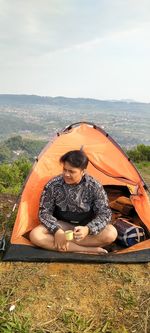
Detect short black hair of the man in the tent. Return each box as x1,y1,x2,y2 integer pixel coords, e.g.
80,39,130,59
60,150,88,170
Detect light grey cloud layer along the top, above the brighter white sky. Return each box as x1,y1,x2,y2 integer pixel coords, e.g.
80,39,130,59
0,0,150,56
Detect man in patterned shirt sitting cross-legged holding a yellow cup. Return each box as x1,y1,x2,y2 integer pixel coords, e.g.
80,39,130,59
30,150,117,254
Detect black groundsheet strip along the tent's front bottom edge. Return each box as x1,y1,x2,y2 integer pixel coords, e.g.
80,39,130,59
2,244,150,263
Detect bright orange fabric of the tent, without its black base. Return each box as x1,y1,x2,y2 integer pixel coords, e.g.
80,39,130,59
2,123,150,258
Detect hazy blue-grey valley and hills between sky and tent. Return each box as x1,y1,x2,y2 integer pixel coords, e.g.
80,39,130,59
0,94,150,147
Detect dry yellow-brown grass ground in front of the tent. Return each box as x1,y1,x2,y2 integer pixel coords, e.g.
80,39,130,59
0,263,150,333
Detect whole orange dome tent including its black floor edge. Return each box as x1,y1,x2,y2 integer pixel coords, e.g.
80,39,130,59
3,123,150,262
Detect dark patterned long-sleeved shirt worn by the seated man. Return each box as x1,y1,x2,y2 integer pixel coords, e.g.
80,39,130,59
39,174,111,235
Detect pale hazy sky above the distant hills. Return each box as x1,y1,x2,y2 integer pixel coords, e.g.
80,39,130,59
0,0,150,102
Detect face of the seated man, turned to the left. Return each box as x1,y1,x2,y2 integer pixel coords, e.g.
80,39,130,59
63,162,84,185
